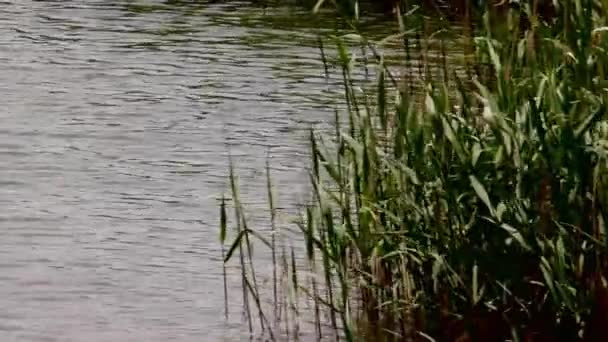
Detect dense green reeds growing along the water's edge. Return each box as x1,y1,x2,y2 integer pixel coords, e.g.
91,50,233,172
220,0,608,342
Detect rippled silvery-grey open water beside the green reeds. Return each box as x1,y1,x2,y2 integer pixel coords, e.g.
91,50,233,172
0,0,358,341
